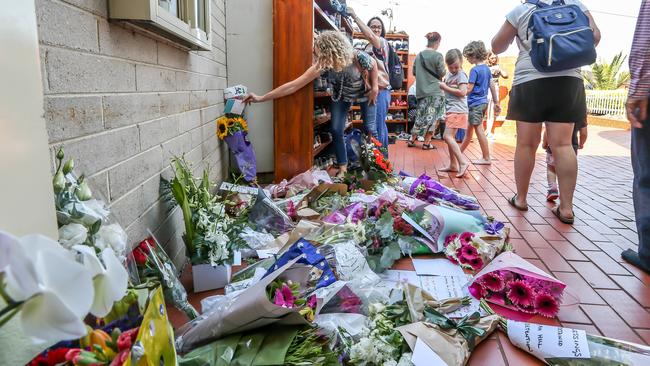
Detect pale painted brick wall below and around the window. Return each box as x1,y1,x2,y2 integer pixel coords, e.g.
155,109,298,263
36,0,228,264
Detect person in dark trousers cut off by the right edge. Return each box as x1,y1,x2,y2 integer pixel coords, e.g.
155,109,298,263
621,0,650,273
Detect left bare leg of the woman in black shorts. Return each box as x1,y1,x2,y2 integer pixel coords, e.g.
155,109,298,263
515,121,540,207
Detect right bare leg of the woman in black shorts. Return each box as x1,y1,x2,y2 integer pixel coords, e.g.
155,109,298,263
546,122,578,218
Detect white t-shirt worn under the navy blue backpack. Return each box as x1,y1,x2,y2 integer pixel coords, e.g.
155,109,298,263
506,0,588,86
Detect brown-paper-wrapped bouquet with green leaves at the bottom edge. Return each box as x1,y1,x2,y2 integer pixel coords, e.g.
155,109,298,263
397,309,499,366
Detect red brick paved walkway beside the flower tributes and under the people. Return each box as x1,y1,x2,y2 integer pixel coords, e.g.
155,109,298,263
390,126,650,365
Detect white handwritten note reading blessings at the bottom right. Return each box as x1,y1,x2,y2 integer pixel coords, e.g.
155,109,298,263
508,320,591,360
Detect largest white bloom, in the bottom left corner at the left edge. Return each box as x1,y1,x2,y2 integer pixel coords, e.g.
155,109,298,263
0,232,93,343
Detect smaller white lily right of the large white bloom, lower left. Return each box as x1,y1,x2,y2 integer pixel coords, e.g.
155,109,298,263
72,245,129,318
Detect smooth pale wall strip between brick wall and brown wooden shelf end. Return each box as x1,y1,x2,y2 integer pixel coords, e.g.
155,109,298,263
226,0,272,173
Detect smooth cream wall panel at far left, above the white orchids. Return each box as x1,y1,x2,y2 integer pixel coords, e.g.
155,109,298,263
0,0,57,238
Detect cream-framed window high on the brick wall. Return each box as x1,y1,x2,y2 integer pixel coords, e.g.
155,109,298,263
108,0,212,51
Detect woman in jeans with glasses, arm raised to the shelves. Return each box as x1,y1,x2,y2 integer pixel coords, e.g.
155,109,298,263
347,7,404,151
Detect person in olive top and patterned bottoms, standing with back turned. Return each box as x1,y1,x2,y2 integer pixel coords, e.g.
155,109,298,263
408,32,447,150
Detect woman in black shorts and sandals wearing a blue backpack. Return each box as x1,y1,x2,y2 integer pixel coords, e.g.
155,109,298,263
492,0,600,224
